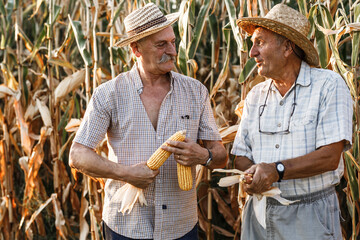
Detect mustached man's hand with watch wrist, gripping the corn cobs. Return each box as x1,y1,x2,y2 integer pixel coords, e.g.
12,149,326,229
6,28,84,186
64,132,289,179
161,138,209,166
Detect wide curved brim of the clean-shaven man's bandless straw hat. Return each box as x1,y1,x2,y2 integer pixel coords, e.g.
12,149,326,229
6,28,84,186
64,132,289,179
236,17,319,67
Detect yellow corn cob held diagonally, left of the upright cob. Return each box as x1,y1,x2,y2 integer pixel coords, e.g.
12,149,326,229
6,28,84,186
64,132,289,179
146,130,186,170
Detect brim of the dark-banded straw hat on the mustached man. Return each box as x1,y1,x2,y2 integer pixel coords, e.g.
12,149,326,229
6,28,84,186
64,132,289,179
115,13,180,47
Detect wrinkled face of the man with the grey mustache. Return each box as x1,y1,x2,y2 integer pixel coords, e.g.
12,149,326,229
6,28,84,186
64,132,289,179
137,26,177,74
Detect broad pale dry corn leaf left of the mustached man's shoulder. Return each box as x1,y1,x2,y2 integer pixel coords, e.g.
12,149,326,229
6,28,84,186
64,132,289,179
54,69,85,104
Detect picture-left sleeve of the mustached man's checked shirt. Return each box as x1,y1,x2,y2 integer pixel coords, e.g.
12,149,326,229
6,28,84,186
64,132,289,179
74,86,111,149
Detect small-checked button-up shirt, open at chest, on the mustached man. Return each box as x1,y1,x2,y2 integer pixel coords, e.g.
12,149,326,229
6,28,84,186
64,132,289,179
74,64,221,239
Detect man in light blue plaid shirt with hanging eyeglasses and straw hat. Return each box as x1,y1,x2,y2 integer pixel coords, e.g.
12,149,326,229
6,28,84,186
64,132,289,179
232,4,353,240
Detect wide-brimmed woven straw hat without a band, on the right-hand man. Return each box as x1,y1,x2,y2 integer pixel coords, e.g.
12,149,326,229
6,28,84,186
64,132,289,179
236,4,319,66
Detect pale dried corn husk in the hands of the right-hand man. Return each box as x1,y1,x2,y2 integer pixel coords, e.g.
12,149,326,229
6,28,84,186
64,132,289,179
213,169,297,229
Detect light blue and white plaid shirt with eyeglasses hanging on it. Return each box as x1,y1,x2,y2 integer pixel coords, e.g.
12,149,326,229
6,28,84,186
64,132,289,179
231,62,353,197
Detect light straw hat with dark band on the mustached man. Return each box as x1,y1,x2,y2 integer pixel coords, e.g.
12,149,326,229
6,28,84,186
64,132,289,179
115,3,179,47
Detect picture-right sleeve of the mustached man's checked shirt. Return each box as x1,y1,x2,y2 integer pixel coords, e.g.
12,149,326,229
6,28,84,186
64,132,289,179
198,87,221,141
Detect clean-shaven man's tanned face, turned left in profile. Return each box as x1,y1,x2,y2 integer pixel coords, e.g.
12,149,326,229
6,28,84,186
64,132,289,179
250,27,286,78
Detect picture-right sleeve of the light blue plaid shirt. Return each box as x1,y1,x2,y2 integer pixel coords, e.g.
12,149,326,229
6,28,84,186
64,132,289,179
316,73,353,151
